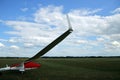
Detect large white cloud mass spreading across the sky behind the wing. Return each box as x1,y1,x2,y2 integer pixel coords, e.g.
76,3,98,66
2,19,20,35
1,5,120,56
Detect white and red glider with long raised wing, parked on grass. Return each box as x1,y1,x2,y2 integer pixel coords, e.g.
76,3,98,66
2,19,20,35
0,15,73,73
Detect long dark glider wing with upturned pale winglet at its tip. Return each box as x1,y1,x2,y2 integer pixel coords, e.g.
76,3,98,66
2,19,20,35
26,15,73,61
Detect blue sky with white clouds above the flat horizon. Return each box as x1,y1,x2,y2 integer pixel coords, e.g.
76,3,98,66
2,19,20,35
0,0,120,57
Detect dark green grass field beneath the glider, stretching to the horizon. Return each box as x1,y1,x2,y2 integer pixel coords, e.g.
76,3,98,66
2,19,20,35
0,58,120,80
